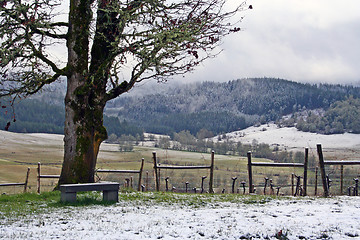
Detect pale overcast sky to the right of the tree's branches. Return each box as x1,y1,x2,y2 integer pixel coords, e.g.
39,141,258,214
178,0,360,84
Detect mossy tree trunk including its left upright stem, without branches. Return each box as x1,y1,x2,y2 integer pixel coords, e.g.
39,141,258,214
58,0,107,186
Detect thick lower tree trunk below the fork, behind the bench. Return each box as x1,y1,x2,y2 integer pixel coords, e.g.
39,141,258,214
59,77,107,184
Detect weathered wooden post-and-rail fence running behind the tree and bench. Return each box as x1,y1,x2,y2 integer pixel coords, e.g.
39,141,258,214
13,144,360,197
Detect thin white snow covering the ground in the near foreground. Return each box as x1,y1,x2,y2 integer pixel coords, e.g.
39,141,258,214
0,193,360,240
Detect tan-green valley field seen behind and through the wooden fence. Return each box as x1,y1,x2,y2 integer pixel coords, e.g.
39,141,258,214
0,131,359,194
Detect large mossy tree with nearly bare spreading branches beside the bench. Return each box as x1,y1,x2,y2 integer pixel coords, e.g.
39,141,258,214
0,0,252,184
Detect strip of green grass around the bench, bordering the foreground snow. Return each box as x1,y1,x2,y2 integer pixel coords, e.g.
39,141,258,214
0,191,285,220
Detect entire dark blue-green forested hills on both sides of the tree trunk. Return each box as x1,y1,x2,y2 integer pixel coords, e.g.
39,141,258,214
0,78,360,136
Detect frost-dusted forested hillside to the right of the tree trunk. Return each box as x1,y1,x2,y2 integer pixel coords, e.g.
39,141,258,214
107,78,360,135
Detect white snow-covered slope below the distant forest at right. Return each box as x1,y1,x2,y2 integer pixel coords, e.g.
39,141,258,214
218,124,360,149
